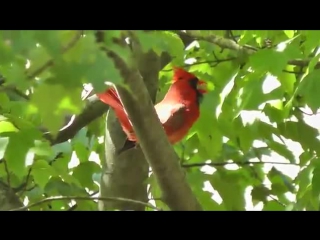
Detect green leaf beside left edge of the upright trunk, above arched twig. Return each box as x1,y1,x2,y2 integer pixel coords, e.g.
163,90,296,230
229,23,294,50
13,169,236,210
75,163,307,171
72,162,101,189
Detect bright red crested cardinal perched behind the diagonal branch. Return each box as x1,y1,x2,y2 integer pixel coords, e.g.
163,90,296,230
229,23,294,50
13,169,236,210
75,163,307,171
97,68,207,153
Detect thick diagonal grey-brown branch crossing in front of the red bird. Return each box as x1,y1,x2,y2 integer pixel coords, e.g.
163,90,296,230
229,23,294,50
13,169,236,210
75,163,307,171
108,43,202,210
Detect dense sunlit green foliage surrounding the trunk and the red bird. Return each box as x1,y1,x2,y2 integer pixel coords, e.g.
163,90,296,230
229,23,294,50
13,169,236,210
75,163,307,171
0,30,320,210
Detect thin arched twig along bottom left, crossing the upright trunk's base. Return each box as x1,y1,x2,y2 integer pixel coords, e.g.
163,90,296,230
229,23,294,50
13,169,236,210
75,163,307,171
10,196,162,211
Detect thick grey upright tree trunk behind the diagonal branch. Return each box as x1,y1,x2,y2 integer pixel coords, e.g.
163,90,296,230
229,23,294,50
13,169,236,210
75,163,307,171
99,51,161,211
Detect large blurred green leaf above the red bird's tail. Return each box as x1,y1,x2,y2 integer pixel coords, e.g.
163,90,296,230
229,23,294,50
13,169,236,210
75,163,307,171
51,33,122,92
